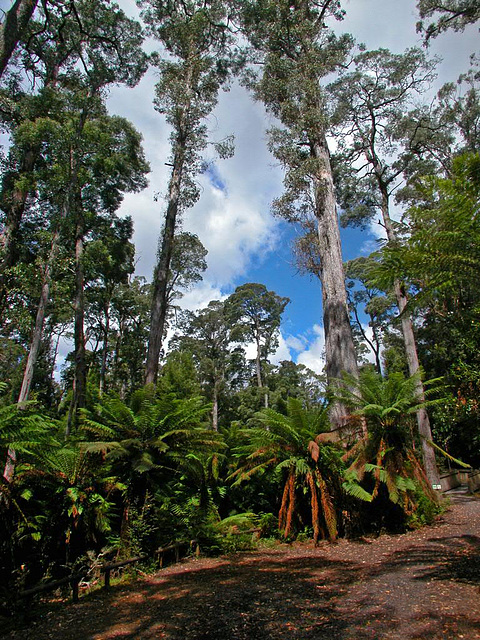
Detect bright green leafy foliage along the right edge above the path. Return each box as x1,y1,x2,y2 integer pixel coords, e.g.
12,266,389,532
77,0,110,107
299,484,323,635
379,153,480,463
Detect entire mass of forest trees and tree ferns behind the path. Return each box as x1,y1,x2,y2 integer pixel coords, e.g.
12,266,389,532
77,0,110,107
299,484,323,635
0,0,480,603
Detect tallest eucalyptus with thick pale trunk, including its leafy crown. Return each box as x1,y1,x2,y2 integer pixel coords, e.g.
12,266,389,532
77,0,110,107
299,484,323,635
240,0,357,426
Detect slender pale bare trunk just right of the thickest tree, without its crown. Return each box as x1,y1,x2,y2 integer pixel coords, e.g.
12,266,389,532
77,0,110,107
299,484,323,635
376,179,440,485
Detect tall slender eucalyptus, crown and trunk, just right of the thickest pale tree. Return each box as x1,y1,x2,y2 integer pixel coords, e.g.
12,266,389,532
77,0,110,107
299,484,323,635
330,49,439,484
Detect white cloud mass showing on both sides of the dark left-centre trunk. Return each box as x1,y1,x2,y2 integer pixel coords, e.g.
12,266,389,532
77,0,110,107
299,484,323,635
109,71,282,298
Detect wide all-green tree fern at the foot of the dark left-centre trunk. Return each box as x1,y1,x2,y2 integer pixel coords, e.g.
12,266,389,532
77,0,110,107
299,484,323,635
83,387,223,516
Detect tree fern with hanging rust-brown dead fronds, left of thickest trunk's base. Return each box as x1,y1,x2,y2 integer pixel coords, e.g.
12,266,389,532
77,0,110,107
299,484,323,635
231,398,341,542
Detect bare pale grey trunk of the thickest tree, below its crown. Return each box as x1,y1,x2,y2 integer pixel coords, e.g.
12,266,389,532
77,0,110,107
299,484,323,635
312,135,358,429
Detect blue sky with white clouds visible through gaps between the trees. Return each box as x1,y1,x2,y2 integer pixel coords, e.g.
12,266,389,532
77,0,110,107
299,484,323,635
109,0,478,371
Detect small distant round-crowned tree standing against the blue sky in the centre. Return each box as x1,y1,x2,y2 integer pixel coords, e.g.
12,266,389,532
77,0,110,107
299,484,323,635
226,282,290,407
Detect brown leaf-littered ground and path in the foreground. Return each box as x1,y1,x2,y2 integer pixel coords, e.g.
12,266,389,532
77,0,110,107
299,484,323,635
6,493,480,640
